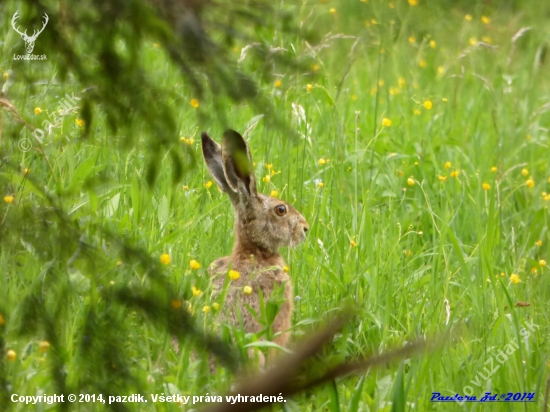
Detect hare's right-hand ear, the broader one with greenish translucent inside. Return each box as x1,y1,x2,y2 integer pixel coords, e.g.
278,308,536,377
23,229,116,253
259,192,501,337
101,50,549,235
222,129,257,197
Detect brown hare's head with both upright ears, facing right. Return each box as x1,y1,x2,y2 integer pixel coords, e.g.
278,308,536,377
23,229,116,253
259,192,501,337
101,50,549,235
201,130,309,254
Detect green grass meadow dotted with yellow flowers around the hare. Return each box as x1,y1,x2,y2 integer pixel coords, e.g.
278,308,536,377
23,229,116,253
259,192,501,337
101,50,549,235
0,0,550,411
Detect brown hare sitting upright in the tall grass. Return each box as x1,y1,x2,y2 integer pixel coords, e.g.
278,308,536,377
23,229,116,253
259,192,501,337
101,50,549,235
201,130,309,363
